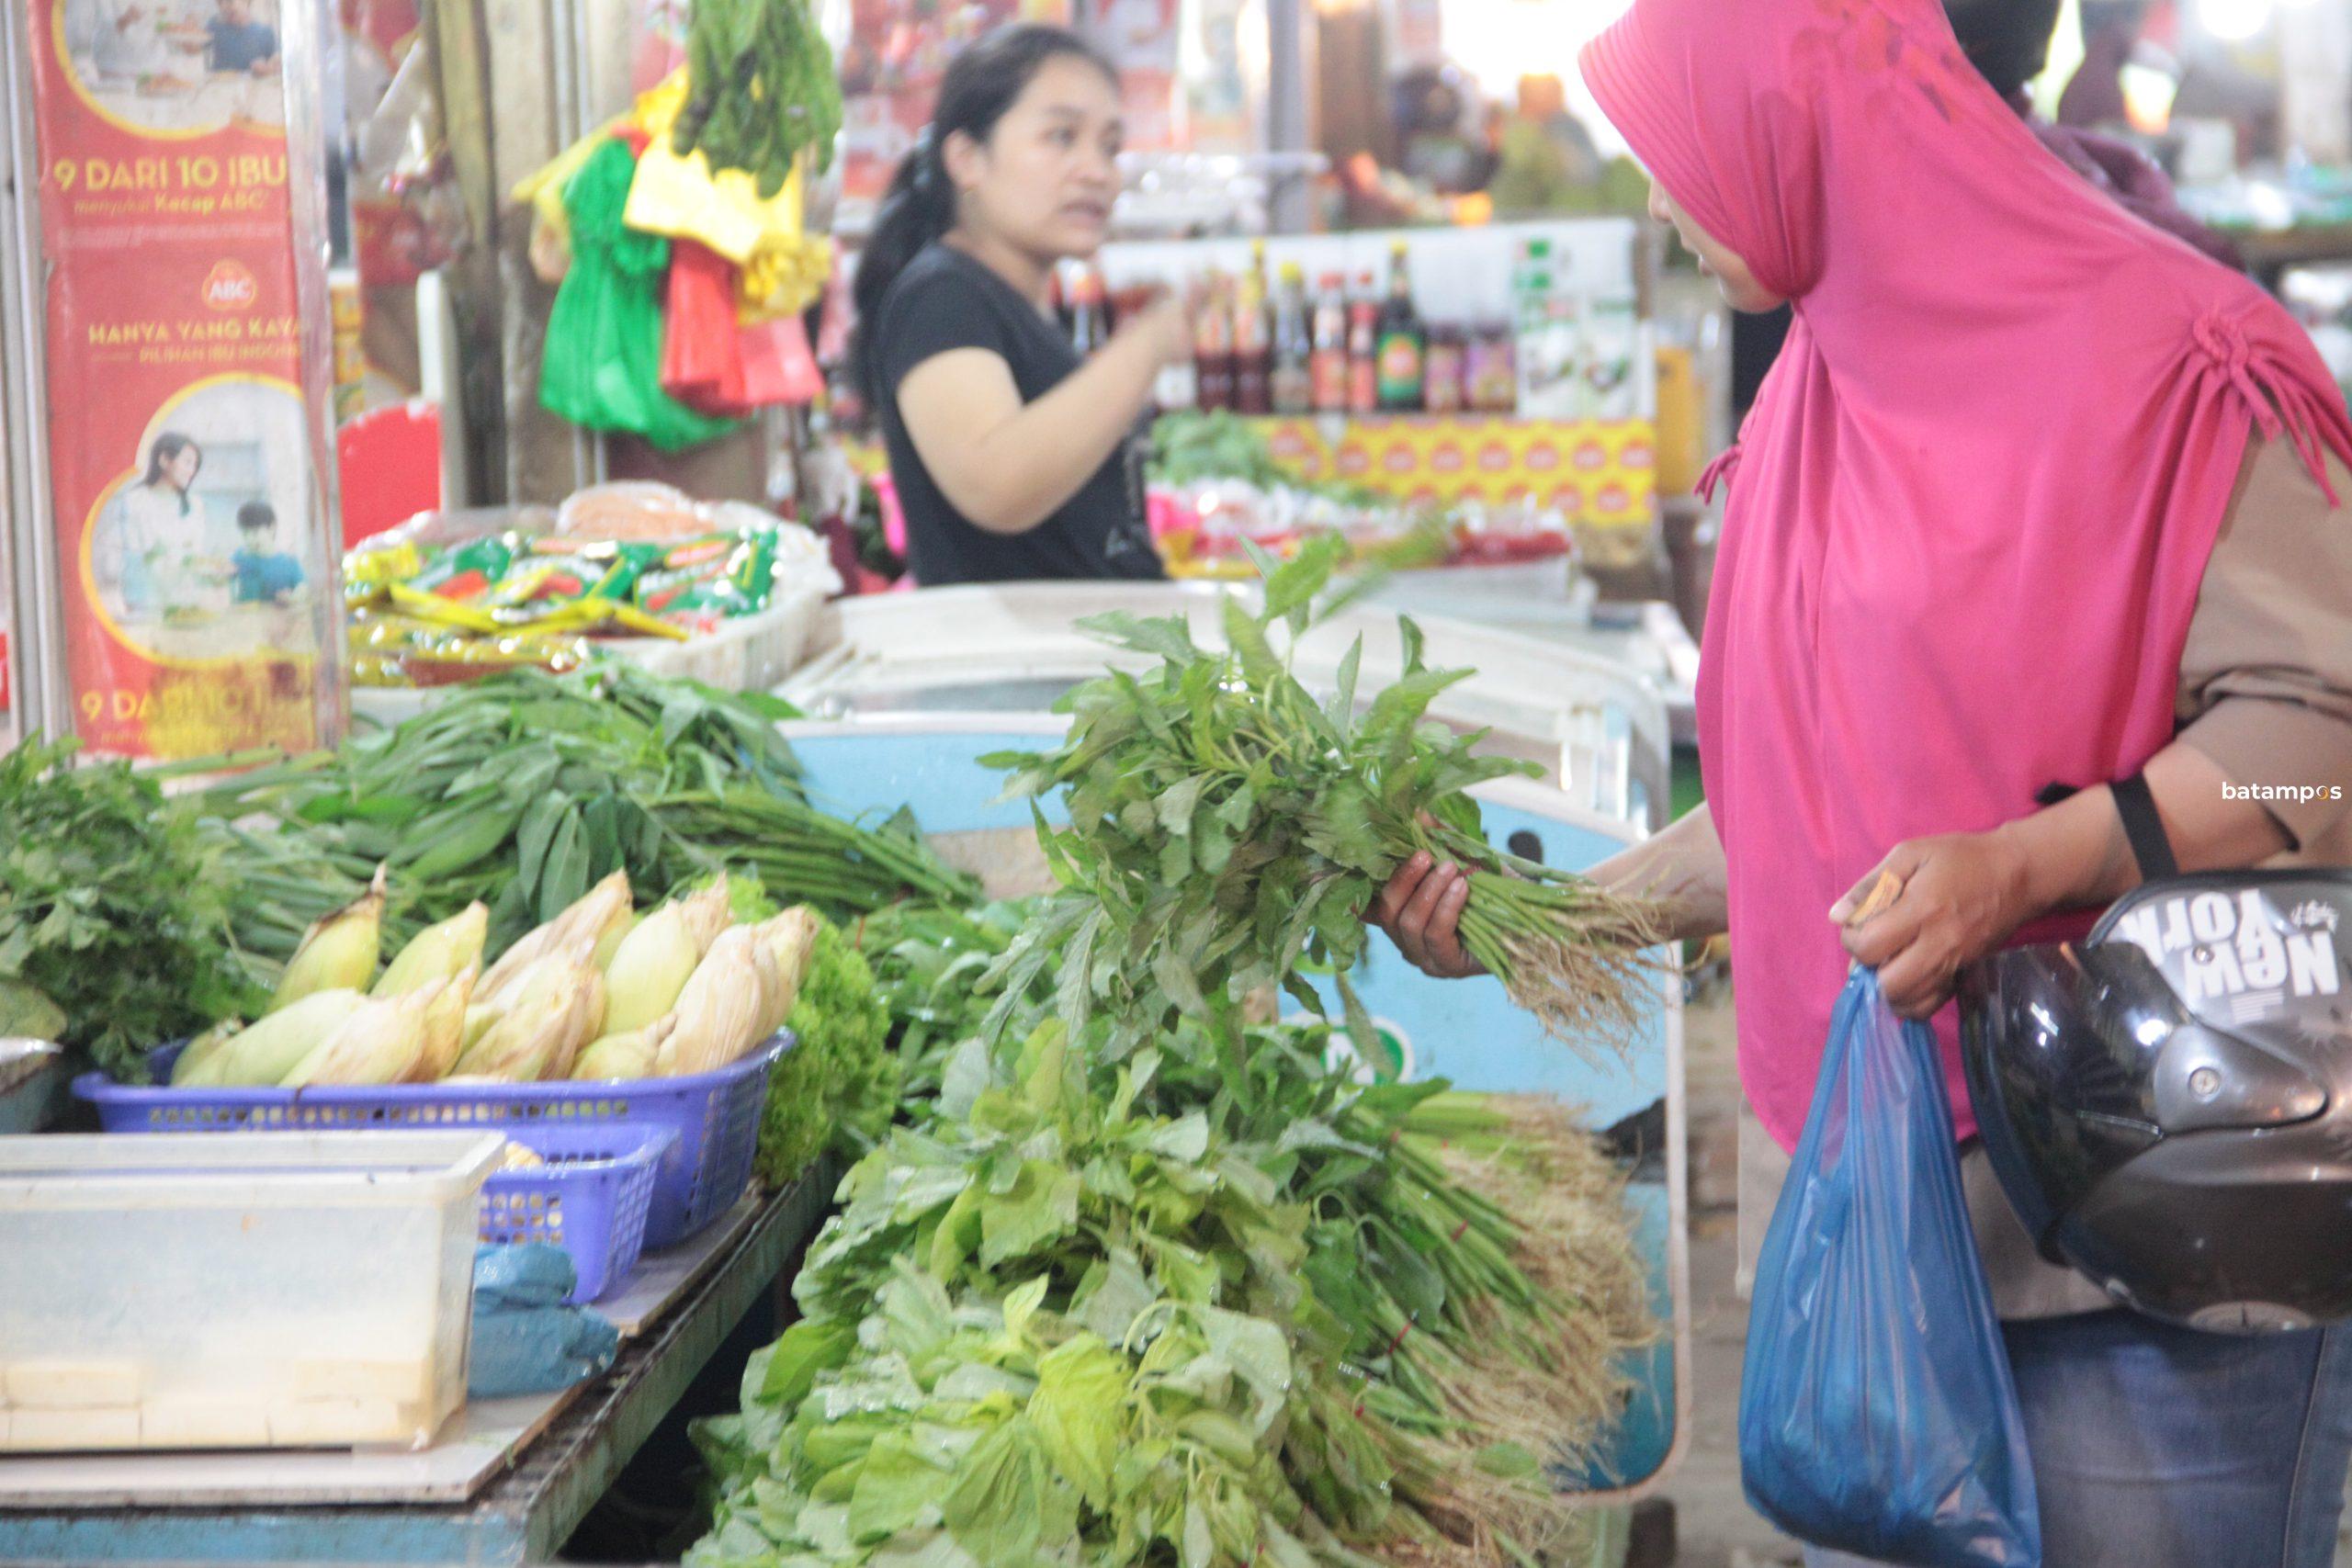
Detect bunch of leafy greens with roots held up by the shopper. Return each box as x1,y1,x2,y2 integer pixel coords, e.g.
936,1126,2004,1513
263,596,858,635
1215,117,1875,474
983,541,1656,1055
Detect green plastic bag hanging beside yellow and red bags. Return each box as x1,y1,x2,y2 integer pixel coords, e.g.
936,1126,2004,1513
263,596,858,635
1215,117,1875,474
538,139,736,451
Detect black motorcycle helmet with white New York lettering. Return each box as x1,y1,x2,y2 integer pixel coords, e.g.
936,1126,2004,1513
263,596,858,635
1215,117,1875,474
1959,870,2352,1333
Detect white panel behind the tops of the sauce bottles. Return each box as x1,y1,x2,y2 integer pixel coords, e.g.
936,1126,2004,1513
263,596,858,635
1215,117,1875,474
1099,219,1639,322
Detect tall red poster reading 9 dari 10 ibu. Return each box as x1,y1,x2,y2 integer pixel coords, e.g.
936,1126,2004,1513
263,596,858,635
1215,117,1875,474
18,0,336,757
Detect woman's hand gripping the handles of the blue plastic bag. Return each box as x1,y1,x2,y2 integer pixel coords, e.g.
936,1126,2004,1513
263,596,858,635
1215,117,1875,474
1830,832,2041,1018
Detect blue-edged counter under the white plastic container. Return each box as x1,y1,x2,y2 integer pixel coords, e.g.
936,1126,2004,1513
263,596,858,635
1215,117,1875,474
0,1166,837,1563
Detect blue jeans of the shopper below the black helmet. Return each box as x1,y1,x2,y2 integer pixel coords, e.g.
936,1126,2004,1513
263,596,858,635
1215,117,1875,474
1804,1312,2352,1568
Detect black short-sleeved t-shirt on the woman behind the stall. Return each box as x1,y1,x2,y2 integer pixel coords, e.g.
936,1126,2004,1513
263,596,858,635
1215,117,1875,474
873,244,1167,588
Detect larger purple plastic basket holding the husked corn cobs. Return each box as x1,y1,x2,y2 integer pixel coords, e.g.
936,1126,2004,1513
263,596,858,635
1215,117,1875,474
73,1030,793,1251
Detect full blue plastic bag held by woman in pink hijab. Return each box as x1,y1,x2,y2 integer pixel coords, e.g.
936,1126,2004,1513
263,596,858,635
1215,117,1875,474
1740,968,2041,1568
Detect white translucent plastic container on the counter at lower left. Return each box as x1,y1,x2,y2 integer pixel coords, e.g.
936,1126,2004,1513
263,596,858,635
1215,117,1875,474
0,1134,503,1453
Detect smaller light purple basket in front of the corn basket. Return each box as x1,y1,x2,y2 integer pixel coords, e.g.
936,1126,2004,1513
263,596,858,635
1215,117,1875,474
480,1122,677,1303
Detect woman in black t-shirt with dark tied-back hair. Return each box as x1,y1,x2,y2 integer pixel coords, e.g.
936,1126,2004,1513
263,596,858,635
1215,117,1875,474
852,26,1193,588
